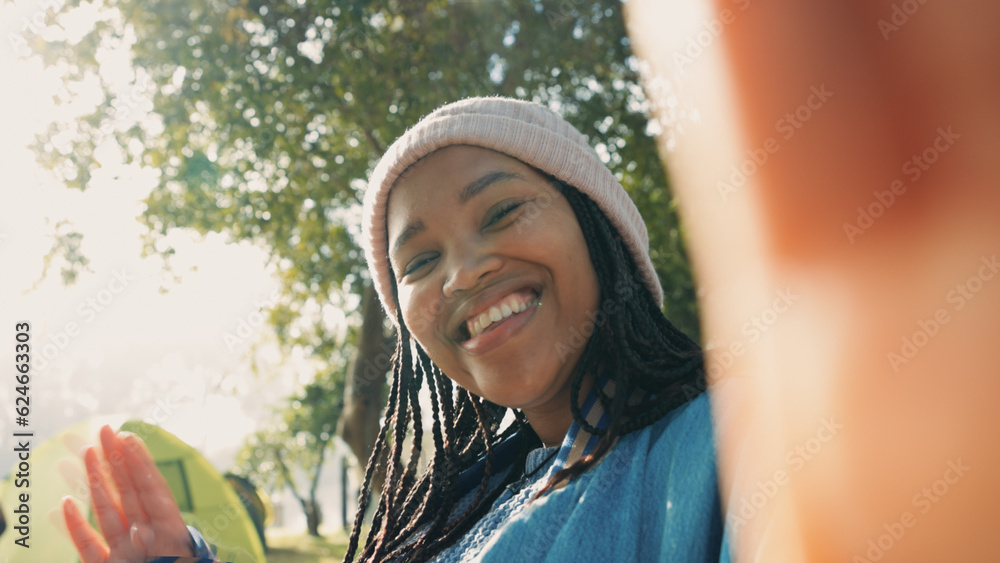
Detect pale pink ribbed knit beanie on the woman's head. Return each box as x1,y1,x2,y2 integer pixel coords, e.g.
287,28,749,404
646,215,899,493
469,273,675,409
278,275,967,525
362,97,663,323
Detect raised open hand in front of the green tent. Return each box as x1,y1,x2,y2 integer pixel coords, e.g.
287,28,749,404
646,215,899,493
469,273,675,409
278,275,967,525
62,426,194,563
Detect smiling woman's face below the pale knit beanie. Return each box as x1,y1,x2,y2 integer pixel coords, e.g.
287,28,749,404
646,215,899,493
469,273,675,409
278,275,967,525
387,145,600,409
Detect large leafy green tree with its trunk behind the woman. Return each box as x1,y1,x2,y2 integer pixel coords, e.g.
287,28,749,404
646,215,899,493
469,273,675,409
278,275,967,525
37,0,698,520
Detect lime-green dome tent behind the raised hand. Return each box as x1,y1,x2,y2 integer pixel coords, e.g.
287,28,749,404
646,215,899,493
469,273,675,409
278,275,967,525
0,419,267,563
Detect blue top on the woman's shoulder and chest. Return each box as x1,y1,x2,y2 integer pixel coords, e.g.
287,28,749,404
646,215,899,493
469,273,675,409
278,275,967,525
176,393,730,563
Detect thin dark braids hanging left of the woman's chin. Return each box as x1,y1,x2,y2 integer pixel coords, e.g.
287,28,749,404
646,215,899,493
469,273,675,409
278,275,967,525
344,302,541,562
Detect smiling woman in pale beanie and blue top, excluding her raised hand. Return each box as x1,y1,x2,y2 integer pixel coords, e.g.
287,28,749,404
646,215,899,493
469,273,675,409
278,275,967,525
67,98,728,563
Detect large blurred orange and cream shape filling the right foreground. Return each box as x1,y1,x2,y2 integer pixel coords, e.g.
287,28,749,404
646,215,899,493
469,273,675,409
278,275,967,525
626,0,1000,563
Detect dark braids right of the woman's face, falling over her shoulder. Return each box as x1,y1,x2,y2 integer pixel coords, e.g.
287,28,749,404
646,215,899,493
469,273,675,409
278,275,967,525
535,182,706,498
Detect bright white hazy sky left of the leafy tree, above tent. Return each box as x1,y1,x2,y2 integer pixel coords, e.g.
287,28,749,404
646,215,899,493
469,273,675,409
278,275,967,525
0,0,344,498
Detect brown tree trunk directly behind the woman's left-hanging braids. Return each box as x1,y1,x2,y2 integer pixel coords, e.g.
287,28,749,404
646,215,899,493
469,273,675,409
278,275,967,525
337,285,395,512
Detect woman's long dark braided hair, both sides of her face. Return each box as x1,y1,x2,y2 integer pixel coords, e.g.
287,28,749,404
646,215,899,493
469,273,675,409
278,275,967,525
344,180,705,562
